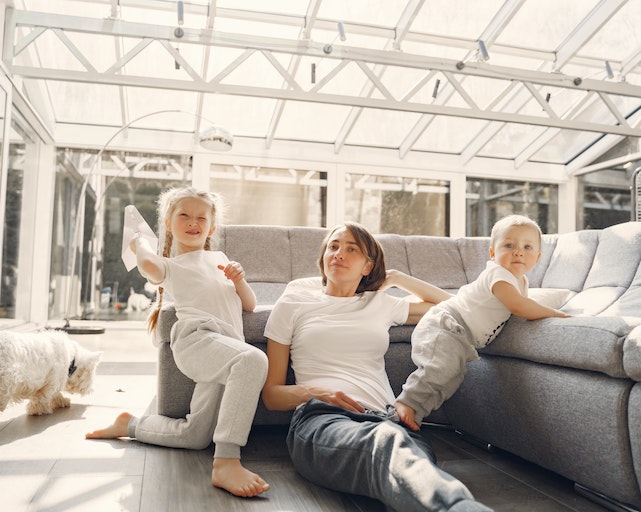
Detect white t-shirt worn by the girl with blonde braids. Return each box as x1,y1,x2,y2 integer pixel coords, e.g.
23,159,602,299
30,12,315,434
158,250,245,340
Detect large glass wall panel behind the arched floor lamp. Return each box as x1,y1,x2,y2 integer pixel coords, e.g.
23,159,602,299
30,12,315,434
50,149,191,320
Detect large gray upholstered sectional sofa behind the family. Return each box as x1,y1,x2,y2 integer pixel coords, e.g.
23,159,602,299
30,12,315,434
157,222,641,510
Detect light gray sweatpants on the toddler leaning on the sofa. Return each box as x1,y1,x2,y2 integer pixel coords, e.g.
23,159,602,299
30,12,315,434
398,305,479,424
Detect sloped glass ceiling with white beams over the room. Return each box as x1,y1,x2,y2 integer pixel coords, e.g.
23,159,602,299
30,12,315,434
3,0,641,179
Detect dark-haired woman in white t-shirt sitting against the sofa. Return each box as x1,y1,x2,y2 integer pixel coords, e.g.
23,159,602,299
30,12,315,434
262,223,490,512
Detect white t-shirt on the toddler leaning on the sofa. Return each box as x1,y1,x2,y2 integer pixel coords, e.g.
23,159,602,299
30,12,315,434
446,260,528,347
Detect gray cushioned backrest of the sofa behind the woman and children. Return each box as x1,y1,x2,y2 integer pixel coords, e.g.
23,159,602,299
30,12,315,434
217,222,641,316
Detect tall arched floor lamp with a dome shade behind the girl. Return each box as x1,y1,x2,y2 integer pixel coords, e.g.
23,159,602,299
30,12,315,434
62,110,233,334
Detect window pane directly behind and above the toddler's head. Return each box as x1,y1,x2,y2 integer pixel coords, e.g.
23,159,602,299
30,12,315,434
466,178,559,236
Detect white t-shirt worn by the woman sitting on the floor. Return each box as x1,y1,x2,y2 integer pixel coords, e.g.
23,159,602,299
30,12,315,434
265,287,409,411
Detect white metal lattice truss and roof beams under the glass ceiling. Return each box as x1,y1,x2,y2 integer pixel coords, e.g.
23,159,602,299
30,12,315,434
3,5,641,156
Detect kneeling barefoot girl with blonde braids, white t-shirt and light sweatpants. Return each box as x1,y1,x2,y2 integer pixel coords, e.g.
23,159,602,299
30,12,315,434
86,187,269,497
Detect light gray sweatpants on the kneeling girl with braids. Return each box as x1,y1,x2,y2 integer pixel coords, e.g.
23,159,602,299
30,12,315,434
129,319,267,459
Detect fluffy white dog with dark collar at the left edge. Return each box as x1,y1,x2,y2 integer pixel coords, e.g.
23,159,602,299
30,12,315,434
0,331,101,415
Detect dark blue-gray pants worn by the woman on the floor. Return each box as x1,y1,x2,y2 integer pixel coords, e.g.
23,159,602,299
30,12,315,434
287,399,491,512
